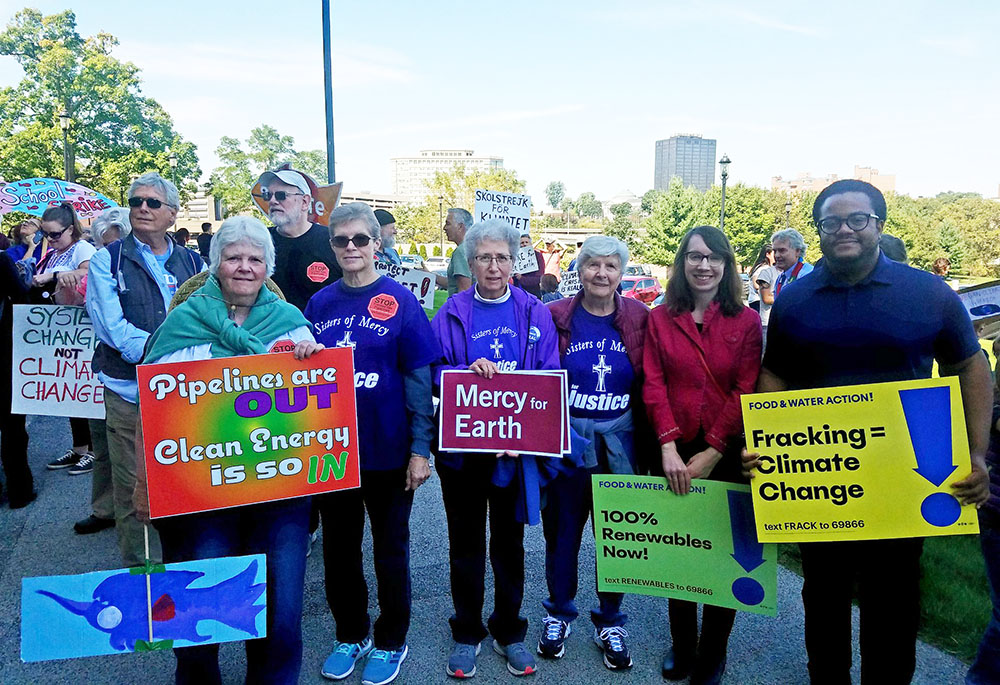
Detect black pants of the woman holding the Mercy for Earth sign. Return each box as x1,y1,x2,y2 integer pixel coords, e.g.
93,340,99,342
438,454,528,646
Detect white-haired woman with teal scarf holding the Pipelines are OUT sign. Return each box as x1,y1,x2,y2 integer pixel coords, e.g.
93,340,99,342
135,216,323,683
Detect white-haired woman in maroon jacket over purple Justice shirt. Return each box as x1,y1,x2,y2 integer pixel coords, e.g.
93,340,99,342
538,236,654,670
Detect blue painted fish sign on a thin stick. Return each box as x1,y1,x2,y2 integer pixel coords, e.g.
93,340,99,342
21,554,267,661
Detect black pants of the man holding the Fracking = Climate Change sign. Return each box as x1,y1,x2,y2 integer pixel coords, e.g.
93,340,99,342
799,538,924,685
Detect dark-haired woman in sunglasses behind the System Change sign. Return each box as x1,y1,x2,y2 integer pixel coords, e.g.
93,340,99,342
32,202,97,476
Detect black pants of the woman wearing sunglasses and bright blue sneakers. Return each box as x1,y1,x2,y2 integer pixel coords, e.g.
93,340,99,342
316,468,413,650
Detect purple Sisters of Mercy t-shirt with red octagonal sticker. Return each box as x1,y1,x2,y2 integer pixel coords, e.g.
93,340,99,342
304,276,441,471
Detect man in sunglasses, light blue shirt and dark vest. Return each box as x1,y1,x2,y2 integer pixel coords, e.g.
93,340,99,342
87,171,205,566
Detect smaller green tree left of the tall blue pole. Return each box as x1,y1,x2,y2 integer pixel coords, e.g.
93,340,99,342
209,124,326,216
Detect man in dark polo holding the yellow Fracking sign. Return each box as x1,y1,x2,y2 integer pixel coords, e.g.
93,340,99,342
744,180,992,685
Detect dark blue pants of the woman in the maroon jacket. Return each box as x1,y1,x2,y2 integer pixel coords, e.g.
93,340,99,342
542,467,628,630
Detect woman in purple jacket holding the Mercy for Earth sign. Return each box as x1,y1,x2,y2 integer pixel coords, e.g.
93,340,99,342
432,219,559,678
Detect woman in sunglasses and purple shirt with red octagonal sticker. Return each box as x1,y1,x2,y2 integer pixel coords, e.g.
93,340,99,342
305,202,441,683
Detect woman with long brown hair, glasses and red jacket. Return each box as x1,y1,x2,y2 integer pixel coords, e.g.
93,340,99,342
642,226,761,685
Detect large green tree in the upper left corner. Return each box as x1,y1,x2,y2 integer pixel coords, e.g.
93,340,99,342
0,9,201,200
